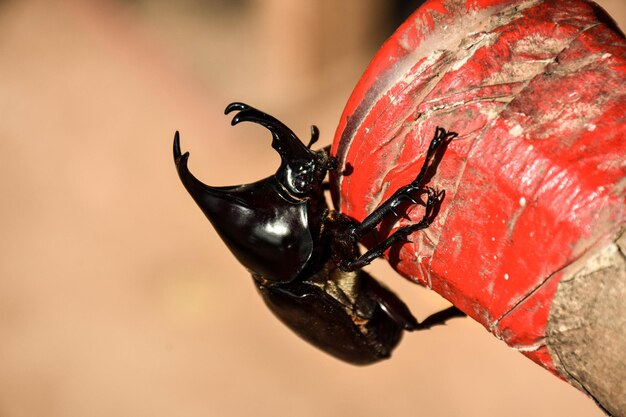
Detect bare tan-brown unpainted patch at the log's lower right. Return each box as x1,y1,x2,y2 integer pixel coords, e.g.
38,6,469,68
546,231,626,417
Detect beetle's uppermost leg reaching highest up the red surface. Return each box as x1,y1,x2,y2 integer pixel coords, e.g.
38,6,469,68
353,127,458,240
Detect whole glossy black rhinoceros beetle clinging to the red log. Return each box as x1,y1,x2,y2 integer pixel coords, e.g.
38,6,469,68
174,103,462,364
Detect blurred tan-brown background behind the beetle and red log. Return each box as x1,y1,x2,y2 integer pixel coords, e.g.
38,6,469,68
0,0,626,417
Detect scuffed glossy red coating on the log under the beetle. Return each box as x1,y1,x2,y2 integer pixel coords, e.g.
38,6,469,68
333,0,626,370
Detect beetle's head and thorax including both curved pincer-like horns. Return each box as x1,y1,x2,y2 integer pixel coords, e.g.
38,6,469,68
174,103,335,282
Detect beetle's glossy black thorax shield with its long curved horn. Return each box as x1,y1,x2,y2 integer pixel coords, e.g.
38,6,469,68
174,128,312,281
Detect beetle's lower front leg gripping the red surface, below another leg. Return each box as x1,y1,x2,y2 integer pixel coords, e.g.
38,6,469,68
339,187,444,271
